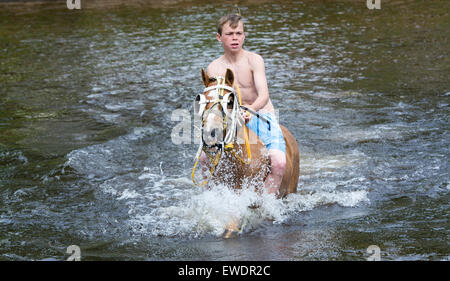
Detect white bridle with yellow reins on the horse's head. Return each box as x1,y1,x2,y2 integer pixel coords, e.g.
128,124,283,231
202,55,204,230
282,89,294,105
192,76,251,186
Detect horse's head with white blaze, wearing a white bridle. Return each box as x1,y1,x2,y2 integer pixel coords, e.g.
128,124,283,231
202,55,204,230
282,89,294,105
194,69,238,148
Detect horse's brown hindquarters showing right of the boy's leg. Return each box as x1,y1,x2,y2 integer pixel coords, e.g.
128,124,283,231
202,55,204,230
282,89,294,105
280,125,300,197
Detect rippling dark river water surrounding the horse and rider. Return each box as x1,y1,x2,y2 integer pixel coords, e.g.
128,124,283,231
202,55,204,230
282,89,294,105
0,0,450,260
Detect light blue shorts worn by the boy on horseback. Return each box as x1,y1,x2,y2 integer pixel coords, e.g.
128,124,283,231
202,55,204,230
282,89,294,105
247,112,286,153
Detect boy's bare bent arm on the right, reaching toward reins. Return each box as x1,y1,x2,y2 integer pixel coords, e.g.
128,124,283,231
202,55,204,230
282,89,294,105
249,54,269,111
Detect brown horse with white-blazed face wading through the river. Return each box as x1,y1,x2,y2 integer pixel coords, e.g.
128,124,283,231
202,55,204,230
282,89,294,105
192,69,300,237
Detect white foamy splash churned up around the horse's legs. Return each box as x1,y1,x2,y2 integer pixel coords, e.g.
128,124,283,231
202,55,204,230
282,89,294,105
124,175,369,237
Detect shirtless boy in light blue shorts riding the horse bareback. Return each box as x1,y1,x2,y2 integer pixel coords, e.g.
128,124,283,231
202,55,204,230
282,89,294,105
206,14,286,194
